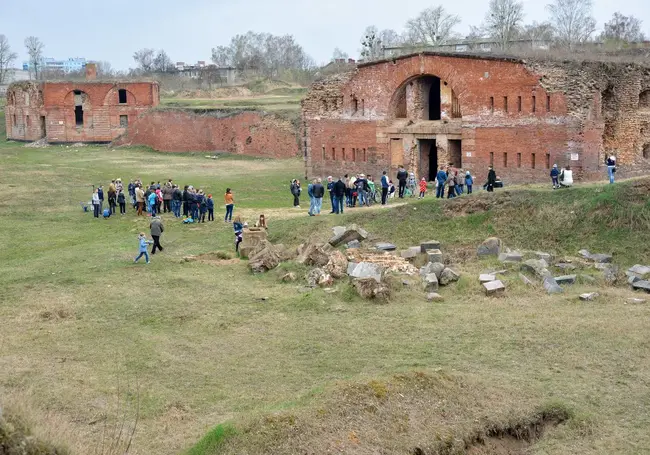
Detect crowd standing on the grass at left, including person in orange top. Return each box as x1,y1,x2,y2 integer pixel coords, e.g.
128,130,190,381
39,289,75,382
91,178,235,223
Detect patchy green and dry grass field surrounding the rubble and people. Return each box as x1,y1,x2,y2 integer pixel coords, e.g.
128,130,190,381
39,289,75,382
0,111,650,455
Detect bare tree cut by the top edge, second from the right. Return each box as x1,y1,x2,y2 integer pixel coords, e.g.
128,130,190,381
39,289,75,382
546,0,596,49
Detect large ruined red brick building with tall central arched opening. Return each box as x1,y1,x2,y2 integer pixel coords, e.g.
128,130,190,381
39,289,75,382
301,52,650,182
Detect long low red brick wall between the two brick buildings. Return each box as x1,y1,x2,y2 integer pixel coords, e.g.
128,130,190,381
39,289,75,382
115,110,299,158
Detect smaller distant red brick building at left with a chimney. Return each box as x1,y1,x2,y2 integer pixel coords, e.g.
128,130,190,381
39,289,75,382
5,64,160,143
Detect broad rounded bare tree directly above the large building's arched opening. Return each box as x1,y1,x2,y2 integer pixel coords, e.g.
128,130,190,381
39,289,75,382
406,6,460,46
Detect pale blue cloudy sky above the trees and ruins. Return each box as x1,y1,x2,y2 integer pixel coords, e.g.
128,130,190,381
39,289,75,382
0,0,650,70
